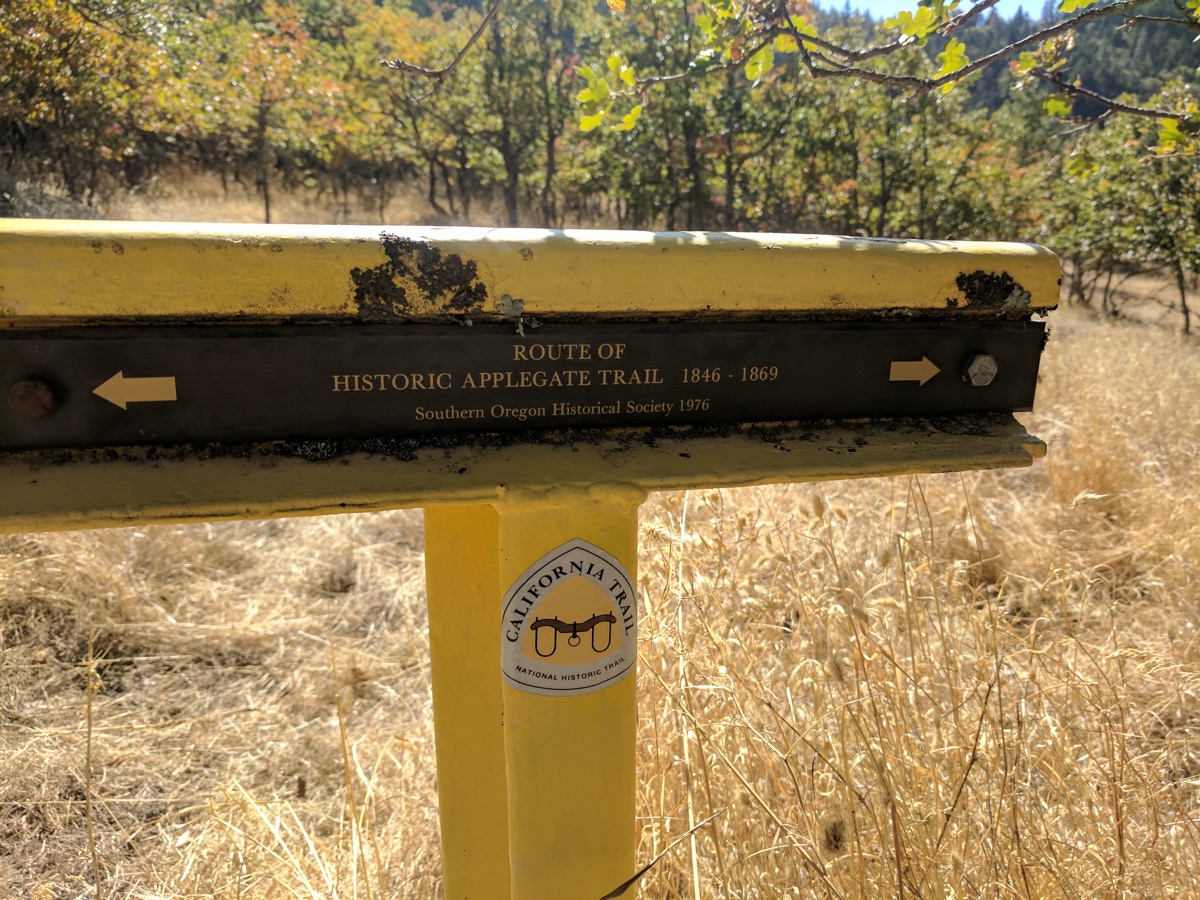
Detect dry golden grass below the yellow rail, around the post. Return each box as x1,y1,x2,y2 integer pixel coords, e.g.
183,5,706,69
0,316,1200,900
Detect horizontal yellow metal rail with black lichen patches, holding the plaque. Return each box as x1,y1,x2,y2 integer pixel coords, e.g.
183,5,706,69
0,220,1058,530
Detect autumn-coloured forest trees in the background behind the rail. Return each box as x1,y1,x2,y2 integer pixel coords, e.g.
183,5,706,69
0,0,1200,328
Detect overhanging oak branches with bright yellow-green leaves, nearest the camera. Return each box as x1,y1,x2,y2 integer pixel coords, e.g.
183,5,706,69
400,0,1200,152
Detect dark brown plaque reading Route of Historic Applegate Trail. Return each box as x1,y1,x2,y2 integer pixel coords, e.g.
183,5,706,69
0,322,1045,449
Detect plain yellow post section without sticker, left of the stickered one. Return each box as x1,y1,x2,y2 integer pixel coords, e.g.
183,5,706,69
425,505,509,900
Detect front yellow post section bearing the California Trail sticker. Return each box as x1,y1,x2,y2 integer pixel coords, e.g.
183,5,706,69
497,486,646,900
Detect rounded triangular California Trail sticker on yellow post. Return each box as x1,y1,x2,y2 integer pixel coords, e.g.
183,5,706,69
500,539,637,696
